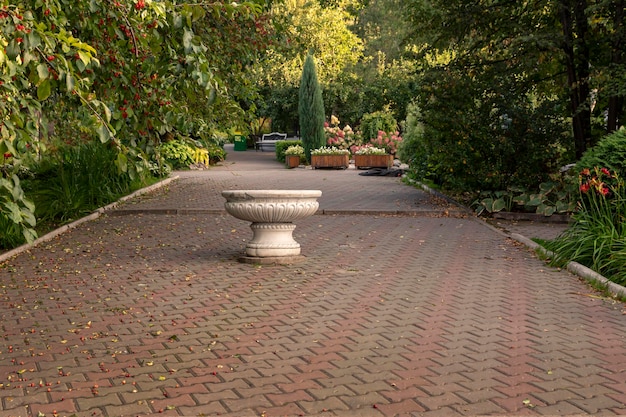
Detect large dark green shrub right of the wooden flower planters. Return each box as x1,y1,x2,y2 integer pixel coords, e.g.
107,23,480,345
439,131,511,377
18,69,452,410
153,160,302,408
419,69,569,191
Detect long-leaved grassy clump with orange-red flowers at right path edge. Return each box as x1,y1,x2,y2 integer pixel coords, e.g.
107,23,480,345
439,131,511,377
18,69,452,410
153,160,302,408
546,168,626,285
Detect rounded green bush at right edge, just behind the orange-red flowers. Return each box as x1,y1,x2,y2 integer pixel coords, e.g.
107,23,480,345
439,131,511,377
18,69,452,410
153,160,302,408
576,127,626,178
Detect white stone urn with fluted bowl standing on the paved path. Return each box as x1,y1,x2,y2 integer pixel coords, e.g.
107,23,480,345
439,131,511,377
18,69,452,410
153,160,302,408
222,190,322,261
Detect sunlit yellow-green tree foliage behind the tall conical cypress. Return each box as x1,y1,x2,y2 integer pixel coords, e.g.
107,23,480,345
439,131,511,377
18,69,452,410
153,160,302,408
255,0,417,141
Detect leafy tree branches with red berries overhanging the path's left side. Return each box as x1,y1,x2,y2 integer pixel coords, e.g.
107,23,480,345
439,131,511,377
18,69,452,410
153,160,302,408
0,0,274,244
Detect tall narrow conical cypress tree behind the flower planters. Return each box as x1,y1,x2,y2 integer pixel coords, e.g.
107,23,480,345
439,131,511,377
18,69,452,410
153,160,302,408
298,54,326,161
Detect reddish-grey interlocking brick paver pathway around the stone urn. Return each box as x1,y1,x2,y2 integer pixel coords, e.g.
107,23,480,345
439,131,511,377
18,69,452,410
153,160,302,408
0,145,626,417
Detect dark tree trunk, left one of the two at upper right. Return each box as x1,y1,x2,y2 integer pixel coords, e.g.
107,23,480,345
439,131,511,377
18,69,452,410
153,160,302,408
559,0,593,158
